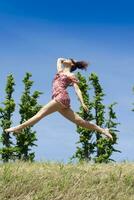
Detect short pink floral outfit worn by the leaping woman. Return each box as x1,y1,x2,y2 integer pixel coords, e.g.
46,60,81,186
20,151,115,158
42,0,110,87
52,70,79,108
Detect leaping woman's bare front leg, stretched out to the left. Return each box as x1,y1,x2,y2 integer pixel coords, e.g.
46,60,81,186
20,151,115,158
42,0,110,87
5,99,60,132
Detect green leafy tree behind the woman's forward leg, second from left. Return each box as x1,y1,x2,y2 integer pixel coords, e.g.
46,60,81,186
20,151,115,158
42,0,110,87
16,73,43,161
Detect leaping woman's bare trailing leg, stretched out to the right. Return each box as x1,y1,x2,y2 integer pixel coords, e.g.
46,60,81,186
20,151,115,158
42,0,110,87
58,108,113,139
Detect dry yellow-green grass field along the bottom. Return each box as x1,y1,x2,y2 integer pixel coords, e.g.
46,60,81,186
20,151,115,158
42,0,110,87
0,161,134,200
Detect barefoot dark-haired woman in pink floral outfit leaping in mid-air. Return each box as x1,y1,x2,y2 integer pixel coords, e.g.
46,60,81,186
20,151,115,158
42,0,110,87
5,58,113,140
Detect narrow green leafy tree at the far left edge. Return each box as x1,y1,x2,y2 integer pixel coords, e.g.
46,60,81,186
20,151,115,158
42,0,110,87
0,74,16,162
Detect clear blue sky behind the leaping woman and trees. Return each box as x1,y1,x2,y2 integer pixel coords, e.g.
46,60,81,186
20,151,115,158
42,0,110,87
0,0,134,162
